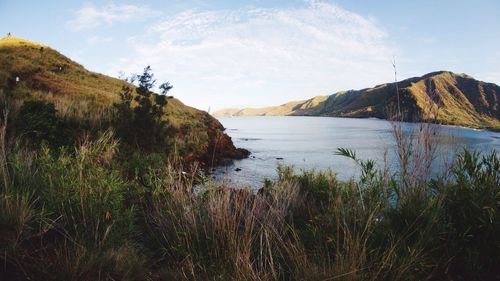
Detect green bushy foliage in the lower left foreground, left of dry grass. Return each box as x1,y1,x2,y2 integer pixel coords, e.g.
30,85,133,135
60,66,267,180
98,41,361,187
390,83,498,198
0,132,145,280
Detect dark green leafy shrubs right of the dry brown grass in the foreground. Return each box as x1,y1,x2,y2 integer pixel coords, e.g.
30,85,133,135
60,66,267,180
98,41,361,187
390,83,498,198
276,149,500,280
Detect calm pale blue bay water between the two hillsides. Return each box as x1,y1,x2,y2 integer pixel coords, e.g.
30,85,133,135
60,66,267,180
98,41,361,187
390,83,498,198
214,116,500,188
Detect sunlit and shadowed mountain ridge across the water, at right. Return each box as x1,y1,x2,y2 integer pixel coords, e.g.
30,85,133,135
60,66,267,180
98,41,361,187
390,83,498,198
214,71,500,129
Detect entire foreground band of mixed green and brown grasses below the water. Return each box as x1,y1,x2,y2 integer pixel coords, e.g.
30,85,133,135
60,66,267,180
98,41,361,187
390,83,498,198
0,131,500,280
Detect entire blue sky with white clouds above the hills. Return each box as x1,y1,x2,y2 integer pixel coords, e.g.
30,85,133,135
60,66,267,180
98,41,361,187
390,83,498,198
0,0,500,111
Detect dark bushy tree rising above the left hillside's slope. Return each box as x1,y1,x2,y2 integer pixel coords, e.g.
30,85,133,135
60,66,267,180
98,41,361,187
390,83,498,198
115,66,173,151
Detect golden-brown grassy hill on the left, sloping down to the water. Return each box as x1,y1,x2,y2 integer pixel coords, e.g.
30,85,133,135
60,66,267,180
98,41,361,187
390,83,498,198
0,36,248,164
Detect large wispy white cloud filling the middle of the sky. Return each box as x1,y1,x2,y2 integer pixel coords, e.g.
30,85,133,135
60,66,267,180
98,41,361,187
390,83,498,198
110,2,395,109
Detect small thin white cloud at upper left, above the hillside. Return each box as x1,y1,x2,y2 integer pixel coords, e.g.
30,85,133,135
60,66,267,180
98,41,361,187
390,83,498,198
68,2,158,30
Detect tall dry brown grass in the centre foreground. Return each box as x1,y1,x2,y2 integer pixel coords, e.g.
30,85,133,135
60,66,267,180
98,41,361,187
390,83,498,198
148,183,301,280
